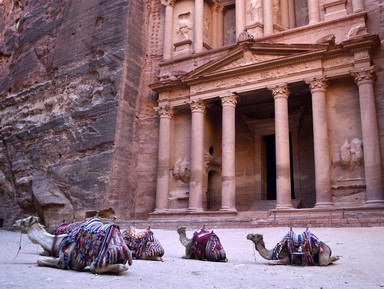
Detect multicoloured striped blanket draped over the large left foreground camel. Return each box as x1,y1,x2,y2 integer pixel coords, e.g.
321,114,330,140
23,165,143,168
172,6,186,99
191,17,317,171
58,218,129,271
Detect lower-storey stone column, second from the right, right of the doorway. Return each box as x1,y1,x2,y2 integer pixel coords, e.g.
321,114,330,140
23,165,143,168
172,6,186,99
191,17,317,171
306,77,333,207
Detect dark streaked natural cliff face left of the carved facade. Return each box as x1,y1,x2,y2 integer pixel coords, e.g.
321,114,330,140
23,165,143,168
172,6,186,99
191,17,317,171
0,0,149,227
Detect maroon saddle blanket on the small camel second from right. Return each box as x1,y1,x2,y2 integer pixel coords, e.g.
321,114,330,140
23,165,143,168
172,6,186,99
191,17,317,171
192,228,227,261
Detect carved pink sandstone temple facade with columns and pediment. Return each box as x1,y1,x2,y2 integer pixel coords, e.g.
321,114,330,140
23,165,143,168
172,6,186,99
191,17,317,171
150,0,384,214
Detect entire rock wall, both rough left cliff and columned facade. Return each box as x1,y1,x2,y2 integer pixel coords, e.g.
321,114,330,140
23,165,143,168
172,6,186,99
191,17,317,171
0,0,384,226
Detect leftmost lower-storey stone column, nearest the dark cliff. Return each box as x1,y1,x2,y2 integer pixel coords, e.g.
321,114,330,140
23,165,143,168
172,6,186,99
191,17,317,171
155,106,172,212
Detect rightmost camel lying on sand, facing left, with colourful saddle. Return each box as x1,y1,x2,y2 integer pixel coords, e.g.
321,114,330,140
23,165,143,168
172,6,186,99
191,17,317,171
247,229,339,266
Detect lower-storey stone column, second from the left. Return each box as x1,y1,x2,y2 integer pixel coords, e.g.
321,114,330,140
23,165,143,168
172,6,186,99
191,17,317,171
188,100,205,211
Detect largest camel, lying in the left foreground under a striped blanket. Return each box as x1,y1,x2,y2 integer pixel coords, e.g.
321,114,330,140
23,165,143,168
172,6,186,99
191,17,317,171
13,216,132,274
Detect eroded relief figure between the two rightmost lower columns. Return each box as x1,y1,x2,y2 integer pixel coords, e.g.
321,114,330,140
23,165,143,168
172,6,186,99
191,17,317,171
340,138,363,170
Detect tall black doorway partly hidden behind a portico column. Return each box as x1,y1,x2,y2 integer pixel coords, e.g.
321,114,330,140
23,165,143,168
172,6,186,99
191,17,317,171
264,134,295,200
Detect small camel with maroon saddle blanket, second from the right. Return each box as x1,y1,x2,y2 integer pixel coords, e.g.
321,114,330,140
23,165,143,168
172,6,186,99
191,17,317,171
177,226,228,262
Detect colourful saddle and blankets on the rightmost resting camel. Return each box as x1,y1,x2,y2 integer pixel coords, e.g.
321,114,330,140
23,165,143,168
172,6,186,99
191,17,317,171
272,229,322,266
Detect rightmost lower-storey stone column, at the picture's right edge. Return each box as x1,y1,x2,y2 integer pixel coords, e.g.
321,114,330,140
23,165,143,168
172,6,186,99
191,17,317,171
352,67,384,206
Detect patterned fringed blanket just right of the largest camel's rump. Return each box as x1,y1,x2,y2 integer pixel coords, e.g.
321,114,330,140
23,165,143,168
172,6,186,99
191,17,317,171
122,226,164,259
